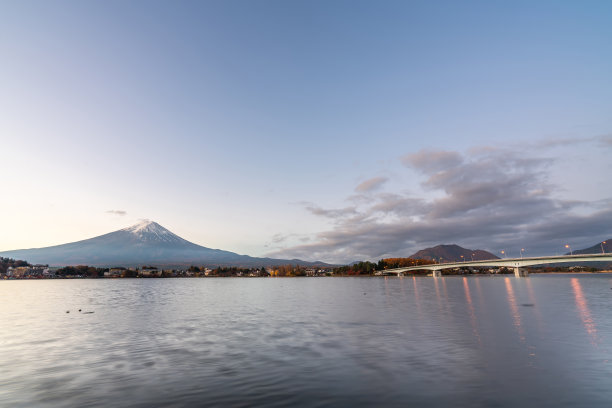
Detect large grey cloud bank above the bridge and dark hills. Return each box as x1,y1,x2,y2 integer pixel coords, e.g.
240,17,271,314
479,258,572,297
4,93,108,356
269,140,612,263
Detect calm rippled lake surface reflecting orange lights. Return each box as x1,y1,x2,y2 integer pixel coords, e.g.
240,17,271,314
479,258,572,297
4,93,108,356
0,275,612,407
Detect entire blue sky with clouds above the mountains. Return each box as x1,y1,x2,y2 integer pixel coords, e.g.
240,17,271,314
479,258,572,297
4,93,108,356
0,1,612,262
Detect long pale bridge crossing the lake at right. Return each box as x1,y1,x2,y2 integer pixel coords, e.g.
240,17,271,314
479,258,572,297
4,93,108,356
382,253,612,278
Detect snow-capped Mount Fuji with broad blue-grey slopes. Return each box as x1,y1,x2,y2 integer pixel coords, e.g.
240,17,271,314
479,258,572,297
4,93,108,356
0,220,324,267
